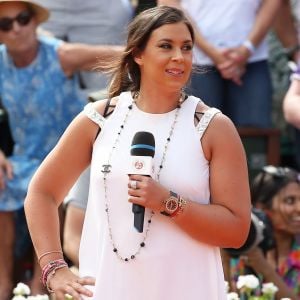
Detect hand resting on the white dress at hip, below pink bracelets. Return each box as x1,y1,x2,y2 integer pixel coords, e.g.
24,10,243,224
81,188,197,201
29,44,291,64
48,268,95,300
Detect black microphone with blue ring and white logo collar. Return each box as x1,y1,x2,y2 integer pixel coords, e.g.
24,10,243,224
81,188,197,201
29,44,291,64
128,131,155,232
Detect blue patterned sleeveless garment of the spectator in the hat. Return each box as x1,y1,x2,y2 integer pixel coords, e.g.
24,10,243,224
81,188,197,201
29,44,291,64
0,37,84,211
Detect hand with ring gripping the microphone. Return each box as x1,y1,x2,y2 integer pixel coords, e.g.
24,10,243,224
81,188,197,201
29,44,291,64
128,175,170,212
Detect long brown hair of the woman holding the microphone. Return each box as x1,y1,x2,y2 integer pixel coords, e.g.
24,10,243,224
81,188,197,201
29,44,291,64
106,6,194,98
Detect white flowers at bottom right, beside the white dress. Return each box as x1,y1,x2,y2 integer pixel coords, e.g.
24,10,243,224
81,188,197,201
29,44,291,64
225,274,290,300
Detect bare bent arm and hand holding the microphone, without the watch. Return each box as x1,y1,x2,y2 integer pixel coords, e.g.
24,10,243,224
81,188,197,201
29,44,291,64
128,115,250,248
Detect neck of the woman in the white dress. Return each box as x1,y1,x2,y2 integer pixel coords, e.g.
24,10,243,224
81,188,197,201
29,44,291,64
136,89,182,114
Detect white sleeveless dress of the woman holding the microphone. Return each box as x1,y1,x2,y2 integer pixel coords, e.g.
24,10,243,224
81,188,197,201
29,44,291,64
80,92,226,300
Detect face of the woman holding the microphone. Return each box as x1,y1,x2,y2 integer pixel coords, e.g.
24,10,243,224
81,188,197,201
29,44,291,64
135,22,193,91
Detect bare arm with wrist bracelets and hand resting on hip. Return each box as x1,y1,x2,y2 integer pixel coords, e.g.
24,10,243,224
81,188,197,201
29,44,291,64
24,101,105,299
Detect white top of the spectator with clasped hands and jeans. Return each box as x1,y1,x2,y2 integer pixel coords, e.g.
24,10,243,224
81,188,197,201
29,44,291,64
181,0,268,65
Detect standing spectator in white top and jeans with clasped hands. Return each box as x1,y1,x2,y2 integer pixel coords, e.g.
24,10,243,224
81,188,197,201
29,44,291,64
158,0,281,128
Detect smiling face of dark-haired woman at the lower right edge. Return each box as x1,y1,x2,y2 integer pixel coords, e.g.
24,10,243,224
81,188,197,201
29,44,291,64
268,182,300,234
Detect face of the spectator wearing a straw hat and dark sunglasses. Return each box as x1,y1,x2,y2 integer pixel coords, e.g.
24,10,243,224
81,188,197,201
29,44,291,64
0,2,37,53
